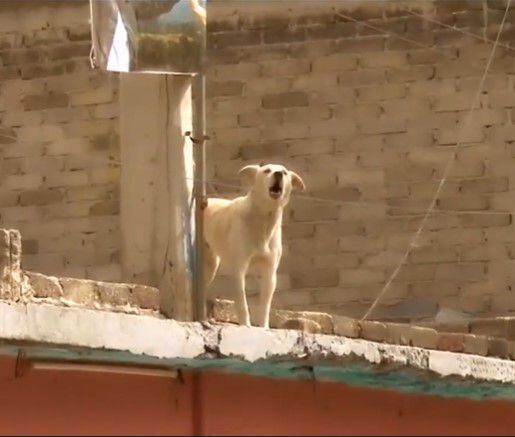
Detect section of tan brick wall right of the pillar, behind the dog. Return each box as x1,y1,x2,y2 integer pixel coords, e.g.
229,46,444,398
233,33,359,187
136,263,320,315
208,0,515,318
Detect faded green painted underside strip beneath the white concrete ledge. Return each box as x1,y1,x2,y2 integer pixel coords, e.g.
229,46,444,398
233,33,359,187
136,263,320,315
0,344,515,400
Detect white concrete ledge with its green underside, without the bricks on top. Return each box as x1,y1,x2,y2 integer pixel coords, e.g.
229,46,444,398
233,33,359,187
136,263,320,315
0,303,515,399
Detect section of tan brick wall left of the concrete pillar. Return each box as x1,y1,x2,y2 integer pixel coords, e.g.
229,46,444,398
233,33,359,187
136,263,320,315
0,1,120,280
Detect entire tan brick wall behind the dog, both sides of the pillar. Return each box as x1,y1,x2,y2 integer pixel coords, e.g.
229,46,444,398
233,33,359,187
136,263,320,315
0,0,515,318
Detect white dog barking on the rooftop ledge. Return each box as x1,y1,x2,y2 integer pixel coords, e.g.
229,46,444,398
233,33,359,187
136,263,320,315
204,164,305,328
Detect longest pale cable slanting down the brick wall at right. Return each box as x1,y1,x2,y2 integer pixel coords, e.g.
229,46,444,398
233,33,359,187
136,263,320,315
361,0,511,320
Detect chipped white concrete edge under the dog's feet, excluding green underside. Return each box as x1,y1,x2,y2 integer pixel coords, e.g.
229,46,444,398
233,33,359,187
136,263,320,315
0,303,515,390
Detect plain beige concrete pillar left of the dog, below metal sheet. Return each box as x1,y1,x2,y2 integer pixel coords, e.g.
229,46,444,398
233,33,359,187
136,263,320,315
120,74,194,320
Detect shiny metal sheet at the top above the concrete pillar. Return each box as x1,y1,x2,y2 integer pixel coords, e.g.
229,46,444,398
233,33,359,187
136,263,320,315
90,0,206,74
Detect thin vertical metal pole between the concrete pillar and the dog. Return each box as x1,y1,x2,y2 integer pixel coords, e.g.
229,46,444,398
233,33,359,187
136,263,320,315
192,74,207,321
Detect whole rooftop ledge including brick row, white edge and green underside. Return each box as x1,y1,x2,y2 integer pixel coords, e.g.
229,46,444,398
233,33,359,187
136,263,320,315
0,229,515,399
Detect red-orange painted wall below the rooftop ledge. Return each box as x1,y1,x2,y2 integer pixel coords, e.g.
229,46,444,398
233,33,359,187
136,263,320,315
0,358,515,435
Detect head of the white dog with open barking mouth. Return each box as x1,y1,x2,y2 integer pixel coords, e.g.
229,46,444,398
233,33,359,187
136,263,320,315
238,164,306,206
